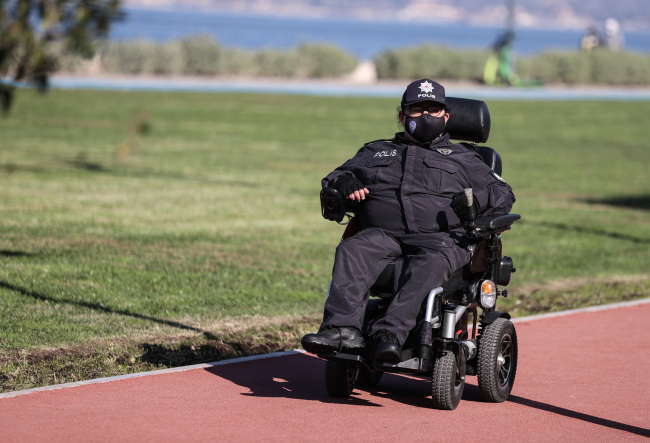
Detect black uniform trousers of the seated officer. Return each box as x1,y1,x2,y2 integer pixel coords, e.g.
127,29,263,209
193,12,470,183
323,228,471,345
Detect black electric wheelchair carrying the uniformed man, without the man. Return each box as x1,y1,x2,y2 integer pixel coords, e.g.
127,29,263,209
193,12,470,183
318,97,520,410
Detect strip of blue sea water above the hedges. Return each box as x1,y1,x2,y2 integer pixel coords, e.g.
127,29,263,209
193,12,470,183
110,9,650,60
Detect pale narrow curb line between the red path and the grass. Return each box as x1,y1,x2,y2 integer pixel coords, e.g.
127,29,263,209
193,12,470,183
0,298,650,398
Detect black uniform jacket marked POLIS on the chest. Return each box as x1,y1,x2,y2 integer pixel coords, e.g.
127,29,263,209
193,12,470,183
322,133,515,234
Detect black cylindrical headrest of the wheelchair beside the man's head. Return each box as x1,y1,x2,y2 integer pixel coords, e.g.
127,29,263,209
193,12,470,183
445,97,490,143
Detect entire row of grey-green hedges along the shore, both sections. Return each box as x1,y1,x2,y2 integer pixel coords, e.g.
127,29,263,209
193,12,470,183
60,35,650,85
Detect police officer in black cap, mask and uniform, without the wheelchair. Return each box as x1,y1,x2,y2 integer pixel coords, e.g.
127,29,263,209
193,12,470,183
302,79,515,361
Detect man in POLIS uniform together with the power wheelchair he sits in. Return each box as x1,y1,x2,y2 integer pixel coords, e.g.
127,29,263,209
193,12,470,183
302,79,520,409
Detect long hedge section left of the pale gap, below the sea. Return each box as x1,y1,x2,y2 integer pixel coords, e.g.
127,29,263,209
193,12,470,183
61,35,358,77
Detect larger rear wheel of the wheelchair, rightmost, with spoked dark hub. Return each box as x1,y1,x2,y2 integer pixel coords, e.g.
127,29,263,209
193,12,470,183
477,318,517,403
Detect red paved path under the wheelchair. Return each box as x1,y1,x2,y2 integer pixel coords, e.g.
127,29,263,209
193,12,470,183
0,304,650,442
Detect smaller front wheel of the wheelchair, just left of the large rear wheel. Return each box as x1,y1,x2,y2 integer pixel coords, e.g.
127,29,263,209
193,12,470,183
431,352,465,411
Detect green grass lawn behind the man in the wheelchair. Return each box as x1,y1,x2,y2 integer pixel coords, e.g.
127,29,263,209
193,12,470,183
0,91,650,389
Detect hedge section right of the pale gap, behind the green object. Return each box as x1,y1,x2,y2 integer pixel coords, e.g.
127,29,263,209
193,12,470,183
374,45,650,85
